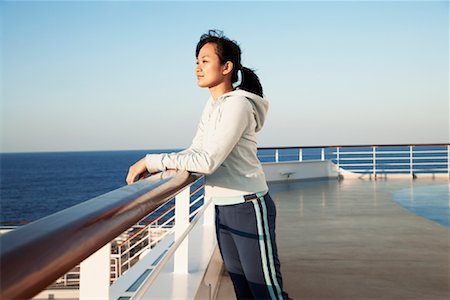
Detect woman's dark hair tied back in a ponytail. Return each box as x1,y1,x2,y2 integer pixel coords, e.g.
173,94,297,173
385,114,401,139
195,30,263,97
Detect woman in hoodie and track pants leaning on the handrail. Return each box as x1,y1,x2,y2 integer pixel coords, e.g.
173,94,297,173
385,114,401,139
126,30,288,299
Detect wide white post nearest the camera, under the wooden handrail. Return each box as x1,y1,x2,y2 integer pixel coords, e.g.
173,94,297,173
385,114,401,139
80,243,111,300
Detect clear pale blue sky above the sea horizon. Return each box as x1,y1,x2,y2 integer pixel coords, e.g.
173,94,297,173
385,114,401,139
0,1,450,152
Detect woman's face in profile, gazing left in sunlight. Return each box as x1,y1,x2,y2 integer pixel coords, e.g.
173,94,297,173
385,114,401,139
195,43,227,88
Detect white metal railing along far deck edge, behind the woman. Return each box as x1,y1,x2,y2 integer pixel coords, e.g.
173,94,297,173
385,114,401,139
258,144,450,176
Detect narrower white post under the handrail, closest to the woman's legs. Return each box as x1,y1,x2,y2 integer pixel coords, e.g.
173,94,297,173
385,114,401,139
174,186,190,274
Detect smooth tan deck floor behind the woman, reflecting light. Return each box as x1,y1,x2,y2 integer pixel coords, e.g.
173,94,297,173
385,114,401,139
217,178,450,300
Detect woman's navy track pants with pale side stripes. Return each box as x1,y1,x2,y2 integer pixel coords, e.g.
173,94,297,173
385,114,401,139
215,193,289,299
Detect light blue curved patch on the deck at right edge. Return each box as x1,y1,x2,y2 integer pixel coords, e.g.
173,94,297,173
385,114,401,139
393,184,450,228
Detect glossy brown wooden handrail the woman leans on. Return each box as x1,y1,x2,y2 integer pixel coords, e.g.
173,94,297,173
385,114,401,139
0,170,201,299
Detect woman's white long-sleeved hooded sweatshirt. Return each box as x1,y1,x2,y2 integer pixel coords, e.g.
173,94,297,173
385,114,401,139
145,89,269,202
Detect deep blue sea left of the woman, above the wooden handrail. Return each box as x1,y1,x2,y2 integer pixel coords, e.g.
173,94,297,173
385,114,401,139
0,150,176,223
